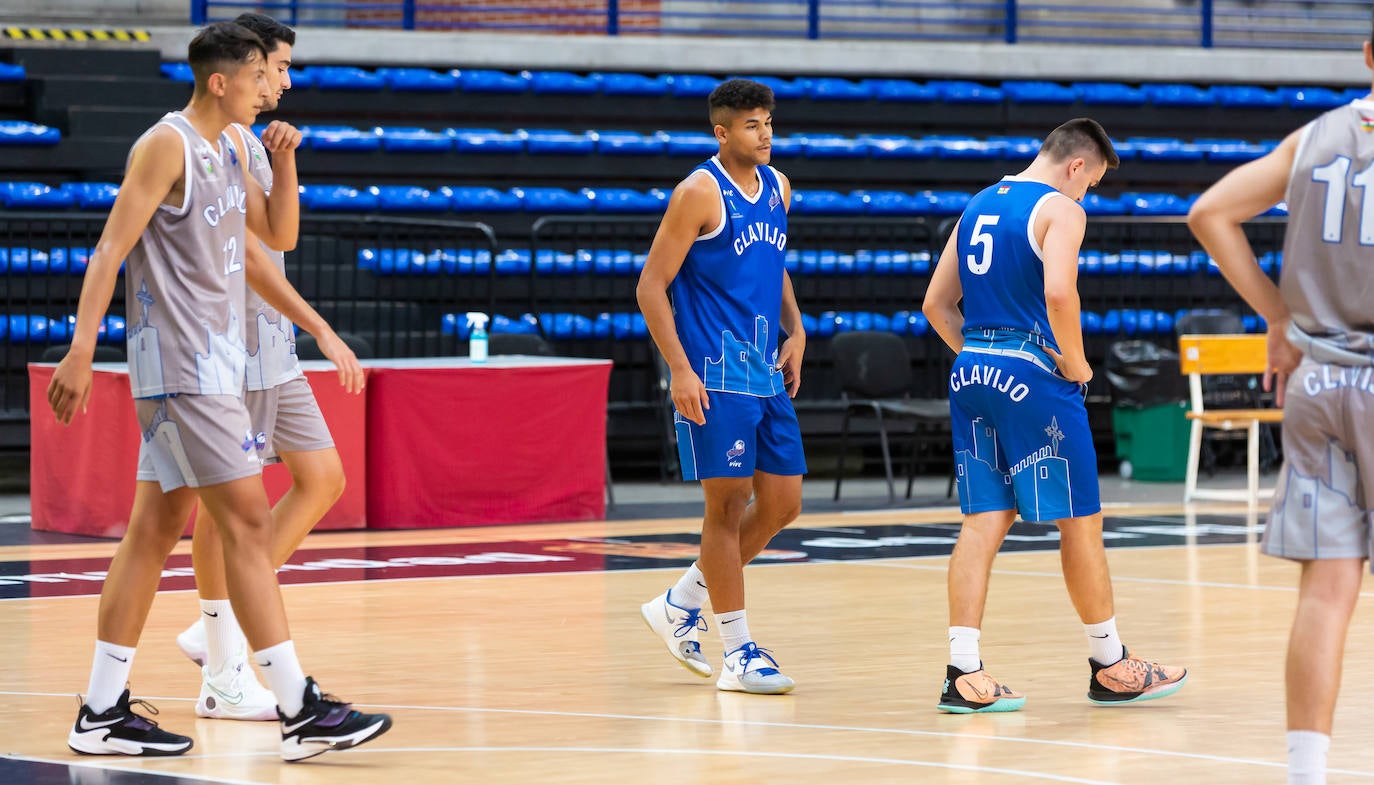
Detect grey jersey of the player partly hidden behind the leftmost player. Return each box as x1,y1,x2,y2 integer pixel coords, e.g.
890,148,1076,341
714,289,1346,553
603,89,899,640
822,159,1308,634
234,125,302,390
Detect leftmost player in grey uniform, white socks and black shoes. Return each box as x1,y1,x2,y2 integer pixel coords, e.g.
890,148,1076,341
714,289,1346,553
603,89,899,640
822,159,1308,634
48,22,390,760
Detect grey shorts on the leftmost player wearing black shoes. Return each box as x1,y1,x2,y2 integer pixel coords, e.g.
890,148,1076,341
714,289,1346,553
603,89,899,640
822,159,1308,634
133,395,262,494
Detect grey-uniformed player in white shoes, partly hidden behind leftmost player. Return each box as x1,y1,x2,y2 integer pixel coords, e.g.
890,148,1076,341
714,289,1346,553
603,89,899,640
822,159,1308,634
177,14,364,720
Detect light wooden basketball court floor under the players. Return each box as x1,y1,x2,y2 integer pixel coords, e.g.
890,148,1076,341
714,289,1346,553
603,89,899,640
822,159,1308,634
0,506,1374,785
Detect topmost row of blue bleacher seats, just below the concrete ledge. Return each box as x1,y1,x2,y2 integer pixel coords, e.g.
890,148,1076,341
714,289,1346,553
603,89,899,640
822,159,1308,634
162,63,1369,109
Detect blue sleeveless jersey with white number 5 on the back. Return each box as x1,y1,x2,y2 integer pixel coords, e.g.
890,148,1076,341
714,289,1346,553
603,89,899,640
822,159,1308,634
958,177,1059,351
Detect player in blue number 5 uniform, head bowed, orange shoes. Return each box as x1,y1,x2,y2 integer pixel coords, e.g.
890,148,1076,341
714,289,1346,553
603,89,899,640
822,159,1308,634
923,118,1187,714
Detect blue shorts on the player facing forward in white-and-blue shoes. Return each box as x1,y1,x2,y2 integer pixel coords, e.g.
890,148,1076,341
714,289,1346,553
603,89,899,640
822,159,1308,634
673,392,807,481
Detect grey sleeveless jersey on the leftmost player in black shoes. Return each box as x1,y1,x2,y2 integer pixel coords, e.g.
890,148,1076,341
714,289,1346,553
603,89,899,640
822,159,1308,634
124,111,247,399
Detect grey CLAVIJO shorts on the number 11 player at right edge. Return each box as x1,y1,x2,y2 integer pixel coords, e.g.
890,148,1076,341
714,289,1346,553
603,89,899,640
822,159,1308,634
1261,360,1374,561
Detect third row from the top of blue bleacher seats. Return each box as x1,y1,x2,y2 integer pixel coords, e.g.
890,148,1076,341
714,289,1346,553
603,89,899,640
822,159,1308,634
0,183,1287,216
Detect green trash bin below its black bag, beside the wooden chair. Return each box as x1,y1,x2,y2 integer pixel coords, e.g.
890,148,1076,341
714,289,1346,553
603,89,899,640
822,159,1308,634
1112,401,1191,483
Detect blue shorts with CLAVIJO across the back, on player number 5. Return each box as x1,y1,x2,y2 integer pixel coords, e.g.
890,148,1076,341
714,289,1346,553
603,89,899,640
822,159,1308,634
949,349,1102,521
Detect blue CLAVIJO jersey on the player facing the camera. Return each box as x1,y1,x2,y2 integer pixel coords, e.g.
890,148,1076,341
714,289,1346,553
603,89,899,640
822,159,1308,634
669,158,787,396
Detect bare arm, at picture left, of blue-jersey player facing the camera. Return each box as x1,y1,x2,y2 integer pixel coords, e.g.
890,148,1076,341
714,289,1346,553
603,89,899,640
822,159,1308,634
635,176,723,425
